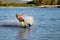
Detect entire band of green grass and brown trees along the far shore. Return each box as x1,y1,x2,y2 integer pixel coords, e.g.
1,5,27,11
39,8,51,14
0,0,60,7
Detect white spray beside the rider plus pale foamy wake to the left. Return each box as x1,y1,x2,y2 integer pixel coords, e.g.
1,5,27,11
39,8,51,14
0,16,33,26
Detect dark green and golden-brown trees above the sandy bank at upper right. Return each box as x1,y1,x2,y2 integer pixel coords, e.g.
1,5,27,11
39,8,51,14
28,0,60,5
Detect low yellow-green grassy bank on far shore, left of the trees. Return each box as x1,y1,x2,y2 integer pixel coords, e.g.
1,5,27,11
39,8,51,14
0,3,36,7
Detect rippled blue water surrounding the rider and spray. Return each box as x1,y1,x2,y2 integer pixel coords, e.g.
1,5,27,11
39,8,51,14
0,7,60,40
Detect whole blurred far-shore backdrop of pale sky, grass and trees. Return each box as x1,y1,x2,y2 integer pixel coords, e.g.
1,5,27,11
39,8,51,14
0,0,60,7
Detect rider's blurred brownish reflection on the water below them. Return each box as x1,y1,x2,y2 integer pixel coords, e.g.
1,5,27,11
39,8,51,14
18,28,30,40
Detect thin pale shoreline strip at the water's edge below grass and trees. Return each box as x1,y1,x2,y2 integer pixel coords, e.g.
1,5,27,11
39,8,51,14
0,5,60,8
